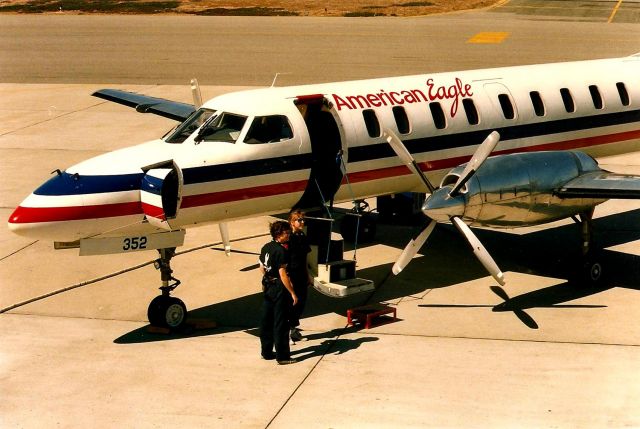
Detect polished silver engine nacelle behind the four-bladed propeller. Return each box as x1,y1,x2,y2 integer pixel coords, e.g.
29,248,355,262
441,151,605,228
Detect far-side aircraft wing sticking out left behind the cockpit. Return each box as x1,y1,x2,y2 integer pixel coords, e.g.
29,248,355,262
91,89,196,122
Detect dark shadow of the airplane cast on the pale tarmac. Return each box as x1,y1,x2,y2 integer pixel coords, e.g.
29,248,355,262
115,209,640,343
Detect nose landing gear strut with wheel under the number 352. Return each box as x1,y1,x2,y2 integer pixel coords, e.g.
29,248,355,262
147,247,187,329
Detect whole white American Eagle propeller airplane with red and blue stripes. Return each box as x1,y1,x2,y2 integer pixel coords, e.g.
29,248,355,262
8,54,640,328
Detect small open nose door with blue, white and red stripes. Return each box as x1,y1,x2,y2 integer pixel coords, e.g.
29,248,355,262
140,161,184,230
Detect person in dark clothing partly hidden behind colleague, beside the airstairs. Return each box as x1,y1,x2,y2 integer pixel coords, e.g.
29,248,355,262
287,209,313,343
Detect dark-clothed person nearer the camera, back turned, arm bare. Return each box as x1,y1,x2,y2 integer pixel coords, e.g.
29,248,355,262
260,221,298,365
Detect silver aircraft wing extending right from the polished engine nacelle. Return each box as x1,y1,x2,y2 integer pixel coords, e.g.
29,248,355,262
555,170,640,199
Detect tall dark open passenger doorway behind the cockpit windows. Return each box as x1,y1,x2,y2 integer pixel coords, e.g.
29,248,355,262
295,94,346,209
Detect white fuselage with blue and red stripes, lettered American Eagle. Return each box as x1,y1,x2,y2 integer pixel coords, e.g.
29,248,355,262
9,56,640,241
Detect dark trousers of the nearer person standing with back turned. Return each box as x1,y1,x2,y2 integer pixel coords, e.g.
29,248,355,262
260,286,291,361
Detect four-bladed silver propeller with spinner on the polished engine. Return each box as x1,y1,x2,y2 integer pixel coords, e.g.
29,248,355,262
384,128,504,286
